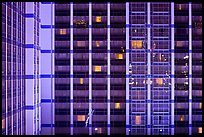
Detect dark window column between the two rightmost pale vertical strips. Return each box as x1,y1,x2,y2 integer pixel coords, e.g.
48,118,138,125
174,3,189,134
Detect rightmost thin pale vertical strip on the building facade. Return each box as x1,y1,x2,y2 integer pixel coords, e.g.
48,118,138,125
189,3,192,135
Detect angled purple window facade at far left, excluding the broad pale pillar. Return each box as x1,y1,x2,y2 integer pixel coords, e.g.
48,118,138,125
2,2,26,135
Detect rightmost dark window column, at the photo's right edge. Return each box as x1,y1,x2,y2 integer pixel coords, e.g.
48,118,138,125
191,3,202,134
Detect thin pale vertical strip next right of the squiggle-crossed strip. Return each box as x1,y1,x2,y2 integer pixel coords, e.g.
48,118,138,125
107,2,110,135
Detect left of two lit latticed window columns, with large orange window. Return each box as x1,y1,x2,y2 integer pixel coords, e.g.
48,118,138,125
129,2,147,135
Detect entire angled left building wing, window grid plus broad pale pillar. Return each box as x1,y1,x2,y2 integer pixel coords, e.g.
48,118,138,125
2,2,41,135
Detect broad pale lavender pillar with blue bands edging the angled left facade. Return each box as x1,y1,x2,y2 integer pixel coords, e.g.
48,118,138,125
24,2,41,135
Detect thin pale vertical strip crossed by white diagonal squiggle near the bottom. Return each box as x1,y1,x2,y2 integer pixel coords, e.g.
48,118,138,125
89,2,92,135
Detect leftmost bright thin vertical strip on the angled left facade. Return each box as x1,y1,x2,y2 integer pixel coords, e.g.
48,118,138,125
5,2,8,135
